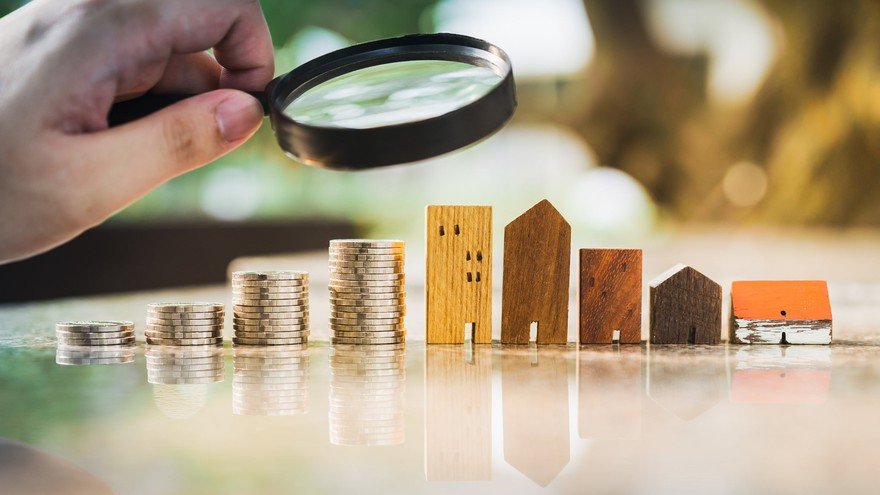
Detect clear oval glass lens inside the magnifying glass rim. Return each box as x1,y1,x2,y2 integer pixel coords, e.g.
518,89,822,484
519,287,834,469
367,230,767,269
284,60,502,129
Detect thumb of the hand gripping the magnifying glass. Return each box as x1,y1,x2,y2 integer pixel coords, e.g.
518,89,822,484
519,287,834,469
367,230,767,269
67,90,263,222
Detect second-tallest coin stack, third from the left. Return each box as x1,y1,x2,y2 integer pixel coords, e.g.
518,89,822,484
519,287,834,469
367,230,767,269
232,270,309,347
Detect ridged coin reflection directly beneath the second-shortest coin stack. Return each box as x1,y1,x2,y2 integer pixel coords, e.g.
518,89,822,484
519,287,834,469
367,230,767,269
144,346,225,385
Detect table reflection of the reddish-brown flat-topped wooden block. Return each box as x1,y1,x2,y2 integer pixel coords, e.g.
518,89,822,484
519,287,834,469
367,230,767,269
577,345,645,439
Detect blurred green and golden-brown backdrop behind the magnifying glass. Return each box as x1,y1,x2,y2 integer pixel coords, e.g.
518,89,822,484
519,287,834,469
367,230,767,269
0,0,880,239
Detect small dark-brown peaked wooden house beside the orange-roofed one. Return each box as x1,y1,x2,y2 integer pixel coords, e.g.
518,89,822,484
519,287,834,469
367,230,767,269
650,264,721,344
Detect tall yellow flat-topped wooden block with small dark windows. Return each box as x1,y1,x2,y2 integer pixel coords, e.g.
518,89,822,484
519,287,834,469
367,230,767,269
425,205,492,344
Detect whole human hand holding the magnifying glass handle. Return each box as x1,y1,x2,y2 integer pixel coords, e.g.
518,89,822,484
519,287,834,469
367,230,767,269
0,0,274,263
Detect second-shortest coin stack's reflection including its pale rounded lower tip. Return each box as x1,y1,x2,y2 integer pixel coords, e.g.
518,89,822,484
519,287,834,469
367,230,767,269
144,345,225,419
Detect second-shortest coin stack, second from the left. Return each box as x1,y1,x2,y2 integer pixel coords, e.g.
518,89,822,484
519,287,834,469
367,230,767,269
144,302,225,345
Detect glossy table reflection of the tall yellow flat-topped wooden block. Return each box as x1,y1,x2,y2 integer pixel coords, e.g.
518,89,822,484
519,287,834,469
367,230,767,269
425,345,492,481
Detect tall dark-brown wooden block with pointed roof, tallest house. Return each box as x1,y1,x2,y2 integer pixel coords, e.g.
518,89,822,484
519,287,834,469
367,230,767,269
501,199,571,344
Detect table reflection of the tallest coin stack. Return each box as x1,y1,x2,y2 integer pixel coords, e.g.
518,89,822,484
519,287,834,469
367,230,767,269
329,344,406,446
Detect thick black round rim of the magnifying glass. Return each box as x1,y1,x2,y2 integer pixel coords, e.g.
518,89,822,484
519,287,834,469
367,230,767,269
267,33,517,170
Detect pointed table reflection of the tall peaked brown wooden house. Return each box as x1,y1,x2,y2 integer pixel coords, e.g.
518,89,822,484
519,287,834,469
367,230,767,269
501,346,576,486
